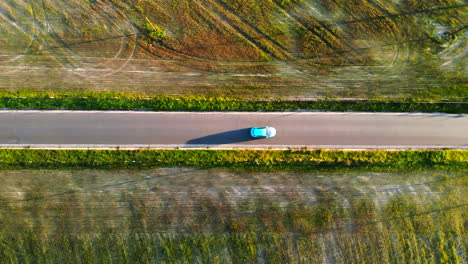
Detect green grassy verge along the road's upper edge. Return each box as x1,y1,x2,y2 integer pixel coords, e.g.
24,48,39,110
0,92,468,114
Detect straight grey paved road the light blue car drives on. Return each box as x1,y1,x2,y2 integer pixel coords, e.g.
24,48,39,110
0,111,468,149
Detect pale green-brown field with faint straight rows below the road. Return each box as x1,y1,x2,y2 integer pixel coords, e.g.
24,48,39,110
0,168,467,263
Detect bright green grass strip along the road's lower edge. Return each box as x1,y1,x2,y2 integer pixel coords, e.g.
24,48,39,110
0,149,468,170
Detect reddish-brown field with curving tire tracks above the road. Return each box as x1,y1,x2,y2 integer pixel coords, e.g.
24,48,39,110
0,0,468,100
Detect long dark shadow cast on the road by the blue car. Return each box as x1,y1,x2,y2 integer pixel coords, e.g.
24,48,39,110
186,128,256,145
